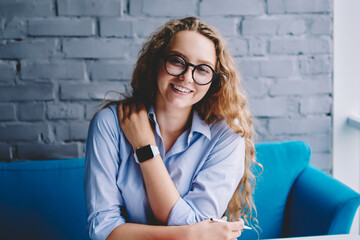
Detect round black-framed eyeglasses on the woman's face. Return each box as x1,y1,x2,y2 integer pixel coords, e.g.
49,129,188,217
164,55,218,85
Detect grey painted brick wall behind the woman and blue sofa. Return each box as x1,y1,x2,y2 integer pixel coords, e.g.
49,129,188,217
0,0,333,171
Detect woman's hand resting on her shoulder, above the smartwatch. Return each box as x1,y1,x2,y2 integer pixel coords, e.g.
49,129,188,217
118,103,156,150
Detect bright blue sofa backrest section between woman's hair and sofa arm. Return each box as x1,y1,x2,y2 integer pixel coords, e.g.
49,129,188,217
240,141,311,239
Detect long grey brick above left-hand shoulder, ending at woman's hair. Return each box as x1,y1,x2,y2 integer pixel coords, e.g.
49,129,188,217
60,81,125,100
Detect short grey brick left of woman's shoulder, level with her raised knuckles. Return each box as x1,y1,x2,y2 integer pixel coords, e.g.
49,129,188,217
47,103,84,120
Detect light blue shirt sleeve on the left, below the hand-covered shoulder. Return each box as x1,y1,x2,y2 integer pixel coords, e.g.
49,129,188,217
84,108,125,240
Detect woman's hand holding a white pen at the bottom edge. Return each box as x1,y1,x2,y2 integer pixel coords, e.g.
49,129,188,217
189,217,244,240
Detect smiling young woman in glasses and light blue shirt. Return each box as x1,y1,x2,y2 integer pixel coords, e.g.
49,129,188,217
85,17,257,240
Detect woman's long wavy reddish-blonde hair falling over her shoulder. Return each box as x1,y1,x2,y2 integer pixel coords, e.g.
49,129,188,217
107,17,261,225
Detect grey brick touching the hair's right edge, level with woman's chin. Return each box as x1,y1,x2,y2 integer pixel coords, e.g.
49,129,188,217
249,98,288,117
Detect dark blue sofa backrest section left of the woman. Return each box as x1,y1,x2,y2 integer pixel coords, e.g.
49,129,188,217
0,159,89,240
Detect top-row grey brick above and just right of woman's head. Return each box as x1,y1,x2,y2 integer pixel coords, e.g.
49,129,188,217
200,0,264,16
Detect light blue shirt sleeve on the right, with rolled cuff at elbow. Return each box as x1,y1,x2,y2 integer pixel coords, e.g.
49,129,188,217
168,128,245,225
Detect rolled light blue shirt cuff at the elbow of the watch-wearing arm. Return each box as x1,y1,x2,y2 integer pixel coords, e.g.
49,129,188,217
167,197,197,226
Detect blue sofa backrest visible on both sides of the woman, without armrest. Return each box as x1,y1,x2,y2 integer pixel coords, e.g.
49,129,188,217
0,142,310,240
